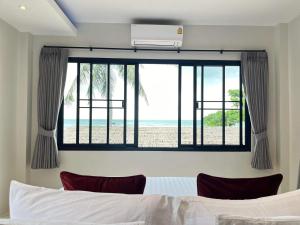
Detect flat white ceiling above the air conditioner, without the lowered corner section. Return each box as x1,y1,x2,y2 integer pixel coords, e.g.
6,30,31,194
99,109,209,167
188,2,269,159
56,0,300,26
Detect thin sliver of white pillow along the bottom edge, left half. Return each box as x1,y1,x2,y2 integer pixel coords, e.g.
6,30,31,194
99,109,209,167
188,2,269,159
0,219,145,225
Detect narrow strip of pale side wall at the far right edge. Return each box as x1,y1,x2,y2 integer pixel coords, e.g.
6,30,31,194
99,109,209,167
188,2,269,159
288,14,300,189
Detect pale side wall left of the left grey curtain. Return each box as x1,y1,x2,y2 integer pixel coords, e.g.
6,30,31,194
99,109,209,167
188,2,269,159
0,20,32,214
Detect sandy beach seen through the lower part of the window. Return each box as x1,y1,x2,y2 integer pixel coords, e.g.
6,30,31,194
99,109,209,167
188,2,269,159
64,126,239,147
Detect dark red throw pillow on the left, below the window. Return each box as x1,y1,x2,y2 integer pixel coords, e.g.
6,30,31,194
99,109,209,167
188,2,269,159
60,171,146,194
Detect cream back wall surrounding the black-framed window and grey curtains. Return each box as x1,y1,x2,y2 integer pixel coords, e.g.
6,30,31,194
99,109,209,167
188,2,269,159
28,24,278,187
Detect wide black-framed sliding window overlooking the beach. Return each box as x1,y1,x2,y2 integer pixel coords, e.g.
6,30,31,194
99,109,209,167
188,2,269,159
58,58,251,151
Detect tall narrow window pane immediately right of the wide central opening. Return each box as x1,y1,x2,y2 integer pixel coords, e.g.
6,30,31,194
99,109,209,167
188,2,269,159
181,66,194,145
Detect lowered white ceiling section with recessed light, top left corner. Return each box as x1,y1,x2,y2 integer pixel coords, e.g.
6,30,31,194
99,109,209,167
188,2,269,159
0,0,77,36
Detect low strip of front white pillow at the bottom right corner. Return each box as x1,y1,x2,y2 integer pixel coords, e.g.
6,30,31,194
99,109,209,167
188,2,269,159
216,215,300,225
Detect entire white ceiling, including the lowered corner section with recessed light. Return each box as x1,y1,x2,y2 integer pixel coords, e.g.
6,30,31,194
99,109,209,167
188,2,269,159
0,0,300,36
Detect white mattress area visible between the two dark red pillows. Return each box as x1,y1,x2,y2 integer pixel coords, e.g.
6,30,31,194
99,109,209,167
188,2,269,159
144,177,197,196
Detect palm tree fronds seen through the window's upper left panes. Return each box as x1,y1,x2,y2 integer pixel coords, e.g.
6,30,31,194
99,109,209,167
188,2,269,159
64,64,149,104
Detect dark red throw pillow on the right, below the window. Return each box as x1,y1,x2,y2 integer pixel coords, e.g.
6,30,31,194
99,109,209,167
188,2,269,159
197,173,283,200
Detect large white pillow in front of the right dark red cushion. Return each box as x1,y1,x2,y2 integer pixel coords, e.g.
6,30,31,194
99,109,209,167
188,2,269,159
178,190,300,225
